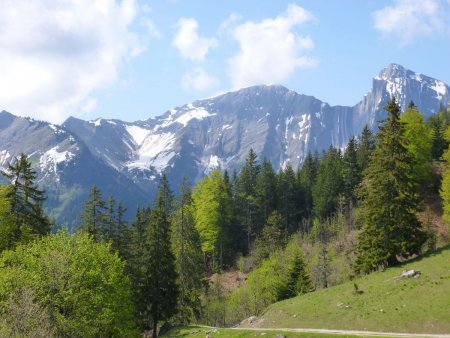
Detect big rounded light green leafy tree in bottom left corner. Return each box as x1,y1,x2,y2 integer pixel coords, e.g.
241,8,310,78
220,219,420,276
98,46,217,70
0,232,136,337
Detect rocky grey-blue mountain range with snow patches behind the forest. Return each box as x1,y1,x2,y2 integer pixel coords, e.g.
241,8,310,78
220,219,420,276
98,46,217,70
0,64,450,225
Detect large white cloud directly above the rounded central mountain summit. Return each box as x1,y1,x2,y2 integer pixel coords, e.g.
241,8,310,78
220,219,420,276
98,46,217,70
228,4,317,89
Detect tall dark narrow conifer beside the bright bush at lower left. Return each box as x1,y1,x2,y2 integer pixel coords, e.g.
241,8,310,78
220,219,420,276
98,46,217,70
140,181,179,338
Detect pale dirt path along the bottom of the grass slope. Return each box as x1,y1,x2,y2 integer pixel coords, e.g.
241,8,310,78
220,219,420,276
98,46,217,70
233,327,450,338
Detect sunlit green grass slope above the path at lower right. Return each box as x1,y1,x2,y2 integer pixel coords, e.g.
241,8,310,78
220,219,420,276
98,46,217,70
243,246,450,334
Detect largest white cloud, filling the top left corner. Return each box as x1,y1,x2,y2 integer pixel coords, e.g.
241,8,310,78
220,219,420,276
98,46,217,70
0,0,143,122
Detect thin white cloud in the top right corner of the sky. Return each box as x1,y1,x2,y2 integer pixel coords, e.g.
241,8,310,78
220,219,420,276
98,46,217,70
373,0,450,45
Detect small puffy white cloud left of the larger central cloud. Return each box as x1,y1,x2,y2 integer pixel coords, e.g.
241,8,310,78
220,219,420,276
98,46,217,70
172,18,218,61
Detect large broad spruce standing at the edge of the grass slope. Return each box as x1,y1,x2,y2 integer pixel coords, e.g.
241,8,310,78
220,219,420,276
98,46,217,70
355,98,426,272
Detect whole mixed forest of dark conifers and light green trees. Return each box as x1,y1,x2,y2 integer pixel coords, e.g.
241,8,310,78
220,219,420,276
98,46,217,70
0,98,450,337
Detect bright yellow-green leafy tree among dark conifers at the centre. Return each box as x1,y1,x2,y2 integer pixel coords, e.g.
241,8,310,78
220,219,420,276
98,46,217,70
192,170,231,270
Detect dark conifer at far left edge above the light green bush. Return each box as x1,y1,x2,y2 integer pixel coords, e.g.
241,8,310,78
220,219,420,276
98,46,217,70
1,154,51,247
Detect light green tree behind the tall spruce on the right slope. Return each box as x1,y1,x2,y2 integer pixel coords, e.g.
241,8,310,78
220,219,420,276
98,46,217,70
400,105,433,182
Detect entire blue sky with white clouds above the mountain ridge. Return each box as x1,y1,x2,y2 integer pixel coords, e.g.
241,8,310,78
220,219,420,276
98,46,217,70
0,0,450,123
